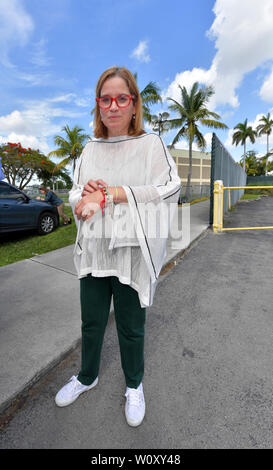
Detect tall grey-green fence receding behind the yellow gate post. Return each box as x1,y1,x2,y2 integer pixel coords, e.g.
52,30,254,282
210,133,246,224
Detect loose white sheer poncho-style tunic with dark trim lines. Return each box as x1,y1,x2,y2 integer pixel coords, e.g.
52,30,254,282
69,134,181,307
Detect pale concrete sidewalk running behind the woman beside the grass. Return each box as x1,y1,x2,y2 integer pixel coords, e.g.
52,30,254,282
0,201,209,412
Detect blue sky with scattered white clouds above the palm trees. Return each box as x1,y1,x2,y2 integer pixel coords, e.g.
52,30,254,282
0,0,273,174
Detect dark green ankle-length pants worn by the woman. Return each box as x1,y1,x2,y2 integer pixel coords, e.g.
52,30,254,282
78,274,146,388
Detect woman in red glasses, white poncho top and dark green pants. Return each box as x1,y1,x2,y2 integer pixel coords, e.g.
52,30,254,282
55,67,180,426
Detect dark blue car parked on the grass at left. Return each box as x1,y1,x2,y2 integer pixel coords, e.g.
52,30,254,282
0,181,59,235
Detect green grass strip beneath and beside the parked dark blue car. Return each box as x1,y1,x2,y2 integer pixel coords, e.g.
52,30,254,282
0,206,77,266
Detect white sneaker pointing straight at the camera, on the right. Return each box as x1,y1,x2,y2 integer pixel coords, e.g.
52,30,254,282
125,383,145,426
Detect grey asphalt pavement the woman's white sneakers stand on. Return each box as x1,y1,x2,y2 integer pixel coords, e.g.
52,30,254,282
0,198,273,449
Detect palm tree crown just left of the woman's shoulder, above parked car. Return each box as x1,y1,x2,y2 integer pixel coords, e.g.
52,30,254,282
48,126,90,172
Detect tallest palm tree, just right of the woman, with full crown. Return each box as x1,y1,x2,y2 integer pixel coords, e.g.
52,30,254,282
167,82,227,201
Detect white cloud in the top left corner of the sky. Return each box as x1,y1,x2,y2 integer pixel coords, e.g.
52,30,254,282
0,0,34,67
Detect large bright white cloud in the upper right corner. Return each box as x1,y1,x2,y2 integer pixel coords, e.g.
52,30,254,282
164,0,273,109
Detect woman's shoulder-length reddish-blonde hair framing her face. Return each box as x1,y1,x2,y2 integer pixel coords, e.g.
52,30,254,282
94,66,145,138
